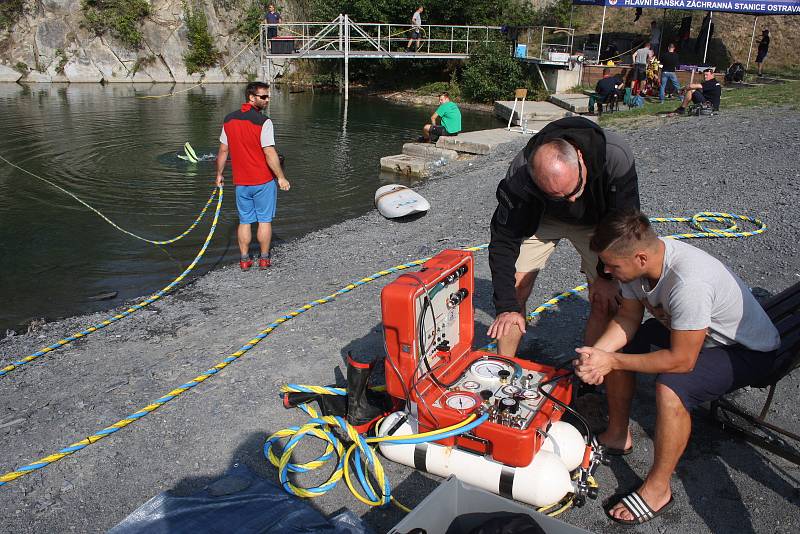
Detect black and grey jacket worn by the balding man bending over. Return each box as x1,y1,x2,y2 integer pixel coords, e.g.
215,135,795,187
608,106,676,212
489,117,639,314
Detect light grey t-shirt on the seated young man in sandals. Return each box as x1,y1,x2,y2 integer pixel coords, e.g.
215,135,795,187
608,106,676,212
620,239,780,352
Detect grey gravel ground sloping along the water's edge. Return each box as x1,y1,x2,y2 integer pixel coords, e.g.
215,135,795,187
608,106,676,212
0,109,800,533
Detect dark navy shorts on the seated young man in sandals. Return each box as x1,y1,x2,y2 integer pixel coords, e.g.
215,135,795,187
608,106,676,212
622,319,778,410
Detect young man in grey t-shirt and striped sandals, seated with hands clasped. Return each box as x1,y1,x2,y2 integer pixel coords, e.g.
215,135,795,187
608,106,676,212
574,210,780,524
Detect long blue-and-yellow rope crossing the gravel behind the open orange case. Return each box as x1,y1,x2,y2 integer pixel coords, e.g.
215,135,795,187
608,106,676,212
0,212,767,486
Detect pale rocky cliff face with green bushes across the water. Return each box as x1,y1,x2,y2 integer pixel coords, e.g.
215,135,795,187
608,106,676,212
0,0,293,83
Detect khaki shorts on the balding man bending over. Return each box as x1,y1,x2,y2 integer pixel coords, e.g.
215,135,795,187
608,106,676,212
516,216,597,282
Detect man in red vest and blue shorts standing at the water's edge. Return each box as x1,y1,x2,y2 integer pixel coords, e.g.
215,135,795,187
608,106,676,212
217,82,290,271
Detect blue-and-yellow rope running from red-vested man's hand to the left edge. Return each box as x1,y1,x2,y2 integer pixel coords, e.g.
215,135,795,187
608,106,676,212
0,187,222,377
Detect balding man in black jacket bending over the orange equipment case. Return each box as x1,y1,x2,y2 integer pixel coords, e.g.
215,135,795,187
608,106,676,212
489,117,639,356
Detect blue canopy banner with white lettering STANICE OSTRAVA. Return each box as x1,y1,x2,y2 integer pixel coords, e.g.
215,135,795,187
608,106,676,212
572,0,800,15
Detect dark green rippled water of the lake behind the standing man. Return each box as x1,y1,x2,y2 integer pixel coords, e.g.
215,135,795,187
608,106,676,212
0,84,500,337
